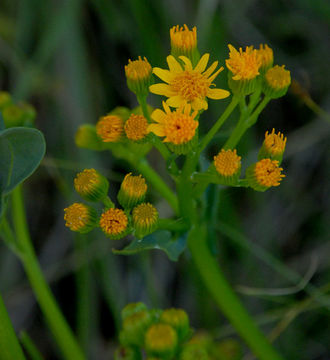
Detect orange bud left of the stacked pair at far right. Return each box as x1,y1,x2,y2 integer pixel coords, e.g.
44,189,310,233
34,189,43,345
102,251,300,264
214,149,241,185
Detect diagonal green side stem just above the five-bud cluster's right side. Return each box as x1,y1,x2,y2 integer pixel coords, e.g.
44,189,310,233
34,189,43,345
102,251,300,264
132,160,179,214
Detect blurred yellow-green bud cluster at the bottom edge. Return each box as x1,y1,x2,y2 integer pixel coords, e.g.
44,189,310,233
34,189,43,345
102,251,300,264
115,302,242,360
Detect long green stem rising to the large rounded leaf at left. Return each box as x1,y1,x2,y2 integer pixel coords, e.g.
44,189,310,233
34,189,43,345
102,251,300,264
12,186,85,360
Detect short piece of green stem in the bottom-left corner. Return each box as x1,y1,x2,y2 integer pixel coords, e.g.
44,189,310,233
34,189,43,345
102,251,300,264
0,296,25,360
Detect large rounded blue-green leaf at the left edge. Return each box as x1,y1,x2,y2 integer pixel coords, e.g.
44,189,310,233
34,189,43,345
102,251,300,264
0,127,46,214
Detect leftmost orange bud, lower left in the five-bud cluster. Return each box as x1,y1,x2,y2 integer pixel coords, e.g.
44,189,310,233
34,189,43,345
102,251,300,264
64,203,97,233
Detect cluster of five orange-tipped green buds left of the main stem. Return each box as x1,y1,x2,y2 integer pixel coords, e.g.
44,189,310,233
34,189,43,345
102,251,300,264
64,169,158,240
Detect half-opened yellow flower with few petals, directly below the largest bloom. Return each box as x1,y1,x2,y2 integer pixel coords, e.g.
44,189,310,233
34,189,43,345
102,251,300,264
148,101,198,145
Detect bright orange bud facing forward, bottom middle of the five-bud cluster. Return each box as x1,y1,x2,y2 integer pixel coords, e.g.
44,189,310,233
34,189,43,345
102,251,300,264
100,208,128,240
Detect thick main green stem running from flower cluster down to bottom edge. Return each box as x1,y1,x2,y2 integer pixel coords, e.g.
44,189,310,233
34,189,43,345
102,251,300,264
188,225,283,360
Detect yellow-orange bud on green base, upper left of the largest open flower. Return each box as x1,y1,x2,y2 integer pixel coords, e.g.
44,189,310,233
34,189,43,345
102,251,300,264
125,56,152,96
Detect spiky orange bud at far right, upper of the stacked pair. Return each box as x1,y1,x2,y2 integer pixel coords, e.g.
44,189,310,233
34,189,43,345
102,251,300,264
258,129,286,164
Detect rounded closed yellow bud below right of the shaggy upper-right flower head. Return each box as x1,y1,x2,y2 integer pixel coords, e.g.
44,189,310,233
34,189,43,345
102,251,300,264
263,65,291,99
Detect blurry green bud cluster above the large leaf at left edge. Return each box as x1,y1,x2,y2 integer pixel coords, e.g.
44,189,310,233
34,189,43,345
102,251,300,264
0,91,36,128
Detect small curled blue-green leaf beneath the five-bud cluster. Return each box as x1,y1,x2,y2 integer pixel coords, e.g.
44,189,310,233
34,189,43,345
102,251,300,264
112,231,187,261
